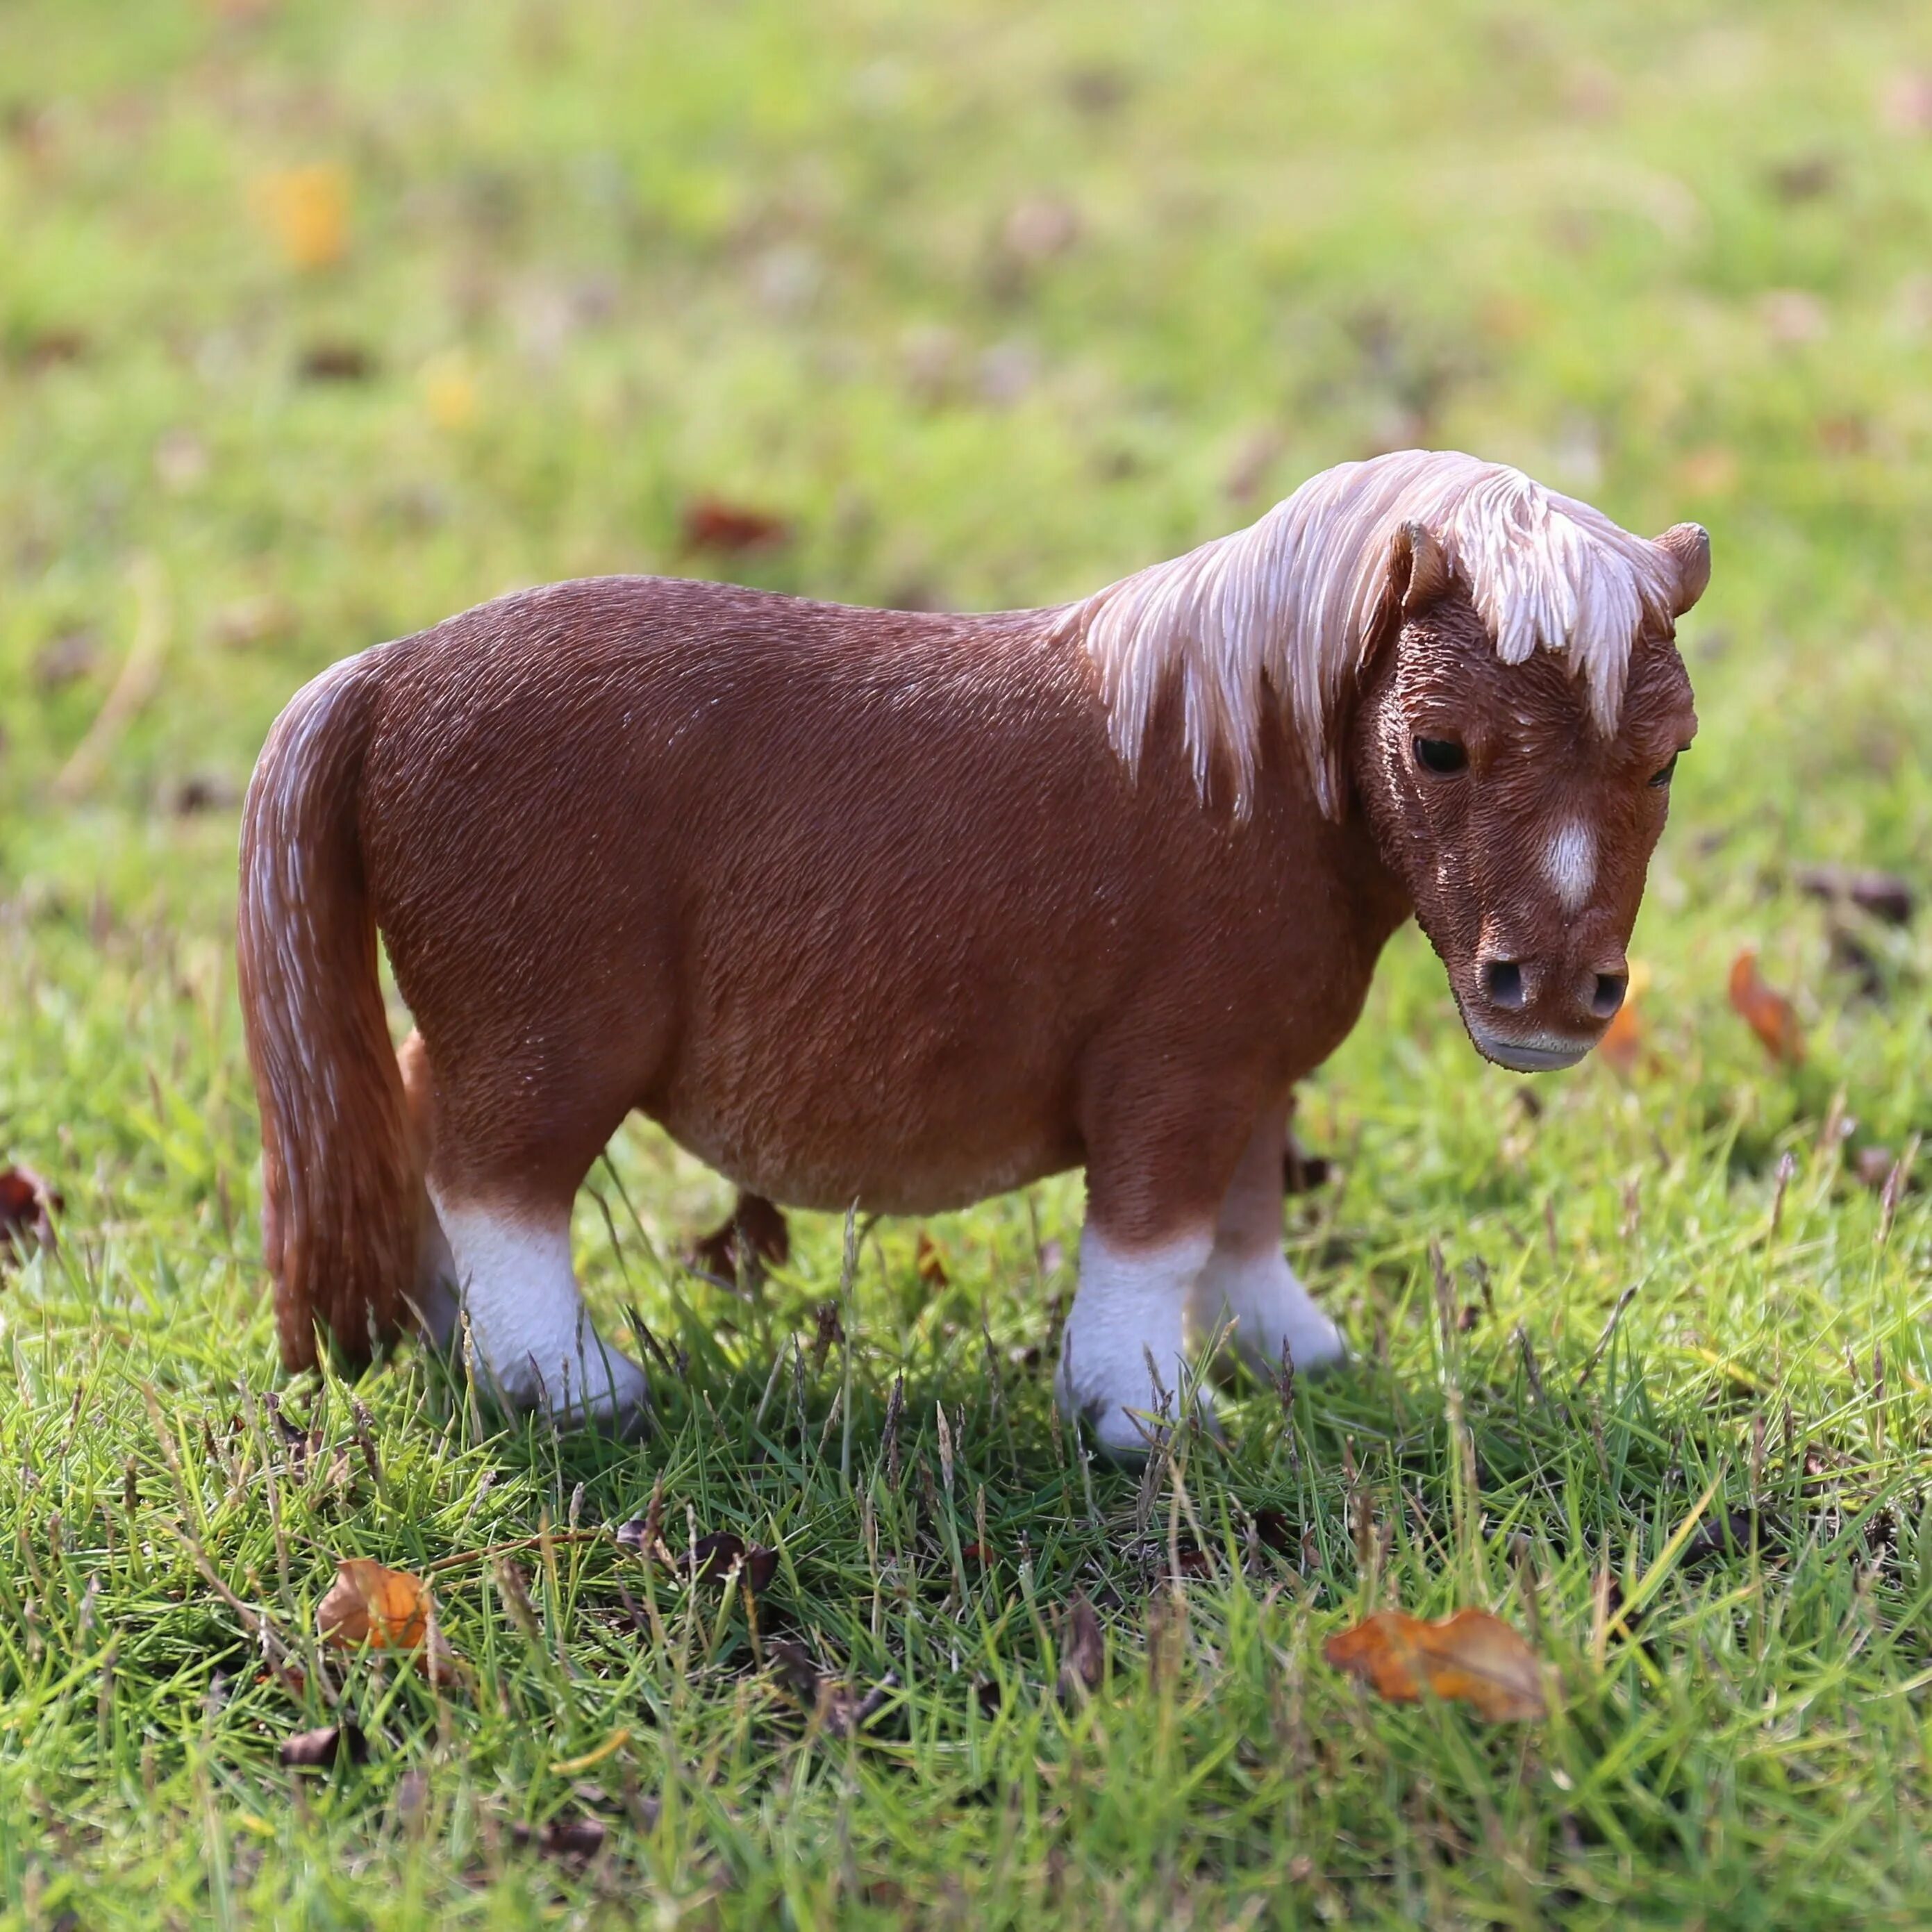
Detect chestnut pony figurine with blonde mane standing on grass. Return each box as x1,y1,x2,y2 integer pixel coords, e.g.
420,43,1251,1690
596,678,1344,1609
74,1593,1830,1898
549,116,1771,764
240,450,1710,1455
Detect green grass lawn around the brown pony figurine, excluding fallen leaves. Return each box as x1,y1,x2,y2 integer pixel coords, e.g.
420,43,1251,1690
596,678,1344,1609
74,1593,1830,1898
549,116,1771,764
0,0,1932,1928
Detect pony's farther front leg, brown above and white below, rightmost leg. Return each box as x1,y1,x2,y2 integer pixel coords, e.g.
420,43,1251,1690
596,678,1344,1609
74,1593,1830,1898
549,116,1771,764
1188,1101,1347,1376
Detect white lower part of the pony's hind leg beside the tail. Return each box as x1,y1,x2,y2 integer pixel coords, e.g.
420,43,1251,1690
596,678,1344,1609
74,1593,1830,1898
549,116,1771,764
431,1190,645,1422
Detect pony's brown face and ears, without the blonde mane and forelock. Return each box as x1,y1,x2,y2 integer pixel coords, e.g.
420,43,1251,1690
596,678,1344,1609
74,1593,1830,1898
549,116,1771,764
1349,524,1710,1072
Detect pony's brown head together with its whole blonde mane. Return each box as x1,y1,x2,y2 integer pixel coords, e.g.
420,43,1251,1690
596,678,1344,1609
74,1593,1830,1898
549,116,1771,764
1072,450,1710,1072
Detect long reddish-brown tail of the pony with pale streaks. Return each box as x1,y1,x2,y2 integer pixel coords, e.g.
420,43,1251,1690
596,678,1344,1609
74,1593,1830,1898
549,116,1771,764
235,653,423,1369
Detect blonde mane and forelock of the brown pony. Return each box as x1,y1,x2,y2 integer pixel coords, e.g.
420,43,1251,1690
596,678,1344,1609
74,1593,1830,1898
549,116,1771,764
1063,450,1675,817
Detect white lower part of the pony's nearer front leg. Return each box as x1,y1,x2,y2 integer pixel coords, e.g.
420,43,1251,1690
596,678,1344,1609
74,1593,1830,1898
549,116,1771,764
1055,1227,1213,1455
